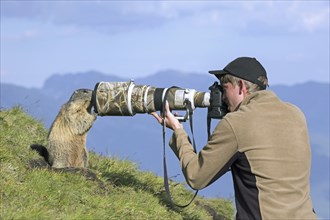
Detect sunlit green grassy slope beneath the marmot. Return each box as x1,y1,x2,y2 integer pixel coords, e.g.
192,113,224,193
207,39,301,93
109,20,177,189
0,107,234,220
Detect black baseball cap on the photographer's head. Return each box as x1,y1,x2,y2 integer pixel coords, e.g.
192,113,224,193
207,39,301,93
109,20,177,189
209,57,267,89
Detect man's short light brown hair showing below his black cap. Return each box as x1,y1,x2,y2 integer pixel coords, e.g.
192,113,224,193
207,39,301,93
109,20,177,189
220,74,268,94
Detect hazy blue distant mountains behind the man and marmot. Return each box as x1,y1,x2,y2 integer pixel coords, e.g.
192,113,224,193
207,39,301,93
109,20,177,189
1,70,330,218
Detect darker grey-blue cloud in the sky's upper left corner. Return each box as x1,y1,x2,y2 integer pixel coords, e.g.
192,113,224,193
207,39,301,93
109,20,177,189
1,1,173,33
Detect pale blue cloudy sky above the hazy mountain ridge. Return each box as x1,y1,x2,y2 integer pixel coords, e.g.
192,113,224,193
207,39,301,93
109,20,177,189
0,0,330,88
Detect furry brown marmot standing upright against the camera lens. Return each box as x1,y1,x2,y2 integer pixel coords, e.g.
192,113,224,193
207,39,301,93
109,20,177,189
31,89,96,168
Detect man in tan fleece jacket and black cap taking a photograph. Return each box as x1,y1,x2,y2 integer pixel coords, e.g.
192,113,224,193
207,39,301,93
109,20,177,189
152,57,316,219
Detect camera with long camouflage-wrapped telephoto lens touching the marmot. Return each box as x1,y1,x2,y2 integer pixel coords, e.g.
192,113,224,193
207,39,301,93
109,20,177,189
92,80,225,118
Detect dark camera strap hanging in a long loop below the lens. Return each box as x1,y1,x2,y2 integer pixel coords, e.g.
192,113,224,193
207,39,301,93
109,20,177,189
161,87,198,208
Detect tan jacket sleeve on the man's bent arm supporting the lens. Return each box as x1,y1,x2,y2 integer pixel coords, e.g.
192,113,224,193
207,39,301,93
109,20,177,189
170,119,238,189
